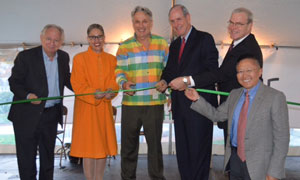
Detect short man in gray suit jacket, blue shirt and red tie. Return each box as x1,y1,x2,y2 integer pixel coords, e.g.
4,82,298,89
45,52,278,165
185,55,290,180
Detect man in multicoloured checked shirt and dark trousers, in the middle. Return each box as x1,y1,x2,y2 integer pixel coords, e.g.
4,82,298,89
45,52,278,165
116,6,169,180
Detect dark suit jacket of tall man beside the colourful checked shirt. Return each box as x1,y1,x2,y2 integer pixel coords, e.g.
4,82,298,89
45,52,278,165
161,27,218,116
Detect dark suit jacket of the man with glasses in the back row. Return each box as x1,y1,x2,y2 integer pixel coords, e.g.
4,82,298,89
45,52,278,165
193,34,263,128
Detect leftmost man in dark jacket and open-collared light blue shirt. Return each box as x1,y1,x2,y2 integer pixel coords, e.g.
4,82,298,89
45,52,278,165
8,24,72,180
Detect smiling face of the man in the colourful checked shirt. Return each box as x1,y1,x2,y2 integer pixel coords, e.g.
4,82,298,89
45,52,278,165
132,11,153,39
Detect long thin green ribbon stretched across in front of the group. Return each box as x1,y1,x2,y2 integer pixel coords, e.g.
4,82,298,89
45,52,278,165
0,86,300,106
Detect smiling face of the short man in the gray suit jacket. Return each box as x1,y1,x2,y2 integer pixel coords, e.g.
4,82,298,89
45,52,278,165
236,58,262,90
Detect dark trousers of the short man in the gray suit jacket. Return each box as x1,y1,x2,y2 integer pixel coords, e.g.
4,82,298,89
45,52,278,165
230,147,251,180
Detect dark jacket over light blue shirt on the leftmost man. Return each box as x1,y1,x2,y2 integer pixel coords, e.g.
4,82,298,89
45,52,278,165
8,46,72,134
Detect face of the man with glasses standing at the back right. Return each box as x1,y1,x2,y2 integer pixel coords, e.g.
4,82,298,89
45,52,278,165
228,12,253,41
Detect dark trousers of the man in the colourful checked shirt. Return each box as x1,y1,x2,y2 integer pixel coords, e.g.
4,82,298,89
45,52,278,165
121,105,165,180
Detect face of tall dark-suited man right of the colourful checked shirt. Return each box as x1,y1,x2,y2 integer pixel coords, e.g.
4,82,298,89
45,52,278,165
169,7,192,37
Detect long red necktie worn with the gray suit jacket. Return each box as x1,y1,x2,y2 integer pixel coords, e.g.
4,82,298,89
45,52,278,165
237,91,249,162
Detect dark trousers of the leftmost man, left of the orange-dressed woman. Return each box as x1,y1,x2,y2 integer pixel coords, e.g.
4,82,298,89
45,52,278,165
13,106,59,180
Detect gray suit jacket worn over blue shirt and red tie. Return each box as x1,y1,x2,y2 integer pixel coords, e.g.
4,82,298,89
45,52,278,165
191,82,290,180
